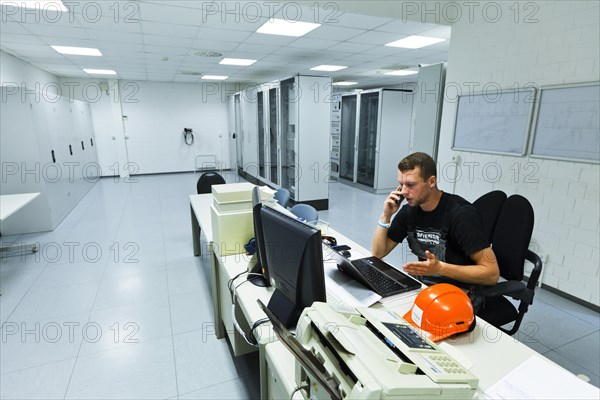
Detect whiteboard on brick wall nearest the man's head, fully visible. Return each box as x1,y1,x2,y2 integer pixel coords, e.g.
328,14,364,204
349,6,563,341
452,89,535,155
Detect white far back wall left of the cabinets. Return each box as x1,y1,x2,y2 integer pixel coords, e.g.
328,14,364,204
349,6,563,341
120,81,231,174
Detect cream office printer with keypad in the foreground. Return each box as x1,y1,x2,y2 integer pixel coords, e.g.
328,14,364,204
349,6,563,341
295,302,478,400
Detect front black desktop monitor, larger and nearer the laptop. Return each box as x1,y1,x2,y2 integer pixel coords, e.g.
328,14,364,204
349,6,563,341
260,207,327,328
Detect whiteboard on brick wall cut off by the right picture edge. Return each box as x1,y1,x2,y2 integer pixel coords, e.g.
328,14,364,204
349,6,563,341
531,82,600,163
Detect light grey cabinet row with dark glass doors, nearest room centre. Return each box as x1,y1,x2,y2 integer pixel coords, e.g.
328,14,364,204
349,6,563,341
230,75,331,210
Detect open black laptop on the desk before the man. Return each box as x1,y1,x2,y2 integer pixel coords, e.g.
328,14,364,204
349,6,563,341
334,252,421,298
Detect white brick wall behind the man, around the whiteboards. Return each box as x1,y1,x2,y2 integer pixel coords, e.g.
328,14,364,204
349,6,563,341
438,1,600,305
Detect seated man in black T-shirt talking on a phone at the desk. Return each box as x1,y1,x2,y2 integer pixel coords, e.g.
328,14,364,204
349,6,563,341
372,153,499,309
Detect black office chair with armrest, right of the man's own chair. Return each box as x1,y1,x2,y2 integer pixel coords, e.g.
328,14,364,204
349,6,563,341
477,194,542,335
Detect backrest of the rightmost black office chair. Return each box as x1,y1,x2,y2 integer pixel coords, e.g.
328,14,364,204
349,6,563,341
492,194,534,281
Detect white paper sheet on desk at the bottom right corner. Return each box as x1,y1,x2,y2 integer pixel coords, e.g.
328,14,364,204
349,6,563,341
483,356,600,400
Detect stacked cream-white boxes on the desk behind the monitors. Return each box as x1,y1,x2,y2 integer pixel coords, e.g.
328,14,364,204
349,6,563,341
210,182,273,256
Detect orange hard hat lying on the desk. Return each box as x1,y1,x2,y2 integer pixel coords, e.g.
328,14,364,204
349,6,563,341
404,283,475,342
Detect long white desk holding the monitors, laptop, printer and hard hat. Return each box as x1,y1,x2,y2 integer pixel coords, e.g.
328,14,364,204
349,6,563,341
190,203,596,398
